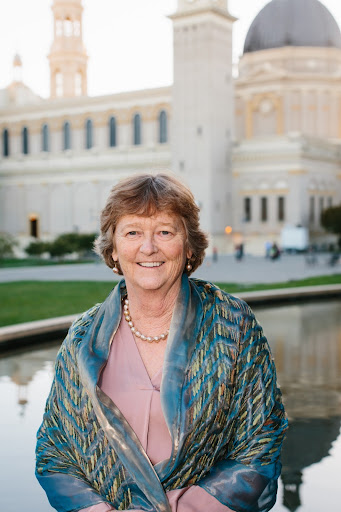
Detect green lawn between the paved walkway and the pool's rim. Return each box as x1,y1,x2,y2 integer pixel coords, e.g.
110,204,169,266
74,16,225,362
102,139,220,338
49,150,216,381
0,274,341,326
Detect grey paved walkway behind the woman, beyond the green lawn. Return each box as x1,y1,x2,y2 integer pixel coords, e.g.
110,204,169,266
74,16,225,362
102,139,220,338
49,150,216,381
0,254,341,284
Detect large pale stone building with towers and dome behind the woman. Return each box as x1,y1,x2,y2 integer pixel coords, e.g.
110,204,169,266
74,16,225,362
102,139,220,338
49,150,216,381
0,0,341,250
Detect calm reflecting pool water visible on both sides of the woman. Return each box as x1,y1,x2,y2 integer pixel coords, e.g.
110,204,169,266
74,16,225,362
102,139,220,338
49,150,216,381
0,301,341,512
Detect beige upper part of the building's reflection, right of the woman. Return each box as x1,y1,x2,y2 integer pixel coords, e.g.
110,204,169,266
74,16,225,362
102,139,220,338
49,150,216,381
256,301,341,418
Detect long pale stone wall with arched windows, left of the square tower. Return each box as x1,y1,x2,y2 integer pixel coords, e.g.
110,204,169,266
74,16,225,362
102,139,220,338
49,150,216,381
0,88,171,242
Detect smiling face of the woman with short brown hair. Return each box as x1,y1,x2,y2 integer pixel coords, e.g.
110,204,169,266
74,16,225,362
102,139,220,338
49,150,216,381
112,212,192,292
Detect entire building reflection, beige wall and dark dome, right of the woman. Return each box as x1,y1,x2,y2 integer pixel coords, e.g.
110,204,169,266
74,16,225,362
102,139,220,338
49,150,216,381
256,301,341,512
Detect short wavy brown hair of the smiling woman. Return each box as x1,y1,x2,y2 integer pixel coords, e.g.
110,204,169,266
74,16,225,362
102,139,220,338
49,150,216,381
95,174,208,275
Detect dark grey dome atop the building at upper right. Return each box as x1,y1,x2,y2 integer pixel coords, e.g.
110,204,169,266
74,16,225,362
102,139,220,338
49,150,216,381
244,0,341,53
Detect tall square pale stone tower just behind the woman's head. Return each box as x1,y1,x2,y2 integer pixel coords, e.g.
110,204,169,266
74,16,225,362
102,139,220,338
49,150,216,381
171,0,236,243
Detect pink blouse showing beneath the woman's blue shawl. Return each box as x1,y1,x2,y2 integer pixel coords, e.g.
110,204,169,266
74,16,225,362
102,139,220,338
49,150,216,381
80,320,232,512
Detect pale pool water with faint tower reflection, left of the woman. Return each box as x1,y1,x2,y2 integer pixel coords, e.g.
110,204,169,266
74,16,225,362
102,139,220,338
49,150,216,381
0,344,59,512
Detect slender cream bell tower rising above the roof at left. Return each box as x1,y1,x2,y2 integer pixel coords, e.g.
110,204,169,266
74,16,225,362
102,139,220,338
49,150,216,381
49,0,88,98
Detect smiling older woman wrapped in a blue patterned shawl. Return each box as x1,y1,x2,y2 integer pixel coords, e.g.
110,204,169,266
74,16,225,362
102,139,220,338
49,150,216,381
36,174,287,512
